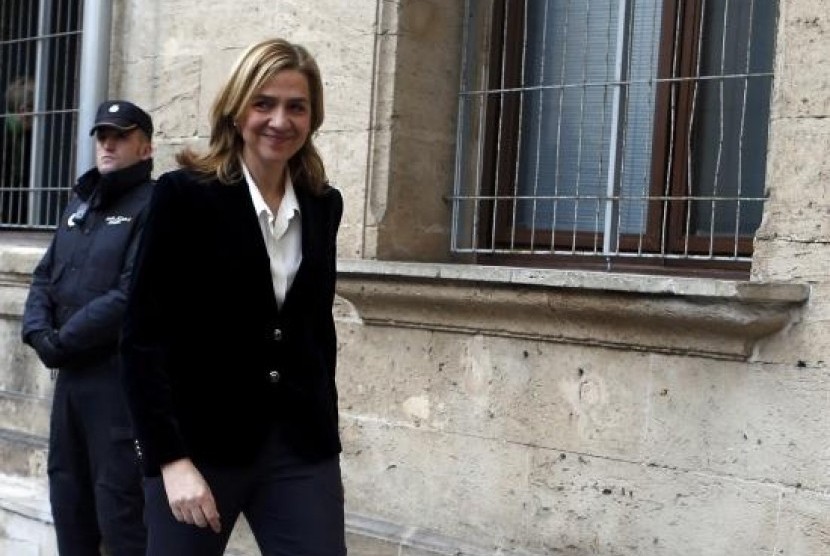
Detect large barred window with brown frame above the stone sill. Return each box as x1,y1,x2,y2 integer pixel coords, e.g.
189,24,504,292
452,0,777,273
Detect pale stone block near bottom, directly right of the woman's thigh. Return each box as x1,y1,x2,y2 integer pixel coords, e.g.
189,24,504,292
342,412,528,552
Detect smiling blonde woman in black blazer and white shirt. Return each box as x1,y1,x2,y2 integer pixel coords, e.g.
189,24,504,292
122,39,346,556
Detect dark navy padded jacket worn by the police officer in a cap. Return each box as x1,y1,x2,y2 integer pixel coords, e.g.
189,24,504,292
22,160,153,368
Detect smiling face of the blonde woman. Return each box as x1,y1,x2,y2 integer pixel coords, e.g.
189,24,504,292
238,70,311,171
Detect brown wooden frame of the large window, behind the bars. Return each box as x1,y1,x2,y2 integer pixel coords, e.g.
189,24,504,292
462,0,774,277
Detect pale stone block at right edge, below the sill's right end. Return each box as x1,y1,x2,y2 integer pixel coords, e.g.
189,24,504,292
640,355,830,490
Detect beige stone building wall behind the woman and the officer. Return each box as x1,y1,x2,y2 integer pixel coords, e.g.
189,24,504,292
0,0,830,556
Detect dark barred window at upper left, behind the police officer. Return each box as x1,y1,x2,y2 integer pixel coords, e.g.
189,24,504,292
0,0,83,229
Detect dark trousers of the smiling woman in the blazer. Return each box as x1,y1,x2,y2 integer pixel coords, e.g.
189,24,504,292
144,427,346,556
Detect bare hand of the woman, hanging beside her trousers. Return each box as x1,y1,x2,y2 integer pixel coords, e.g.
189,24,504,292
161,458,222,533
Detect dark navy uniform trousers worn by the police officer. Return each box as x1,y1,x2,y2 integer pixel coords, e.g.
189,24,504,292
47,366,147,556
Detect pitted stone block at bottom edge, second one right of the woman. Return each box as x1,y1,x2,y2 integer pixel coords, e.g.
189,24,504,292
522,450,781,556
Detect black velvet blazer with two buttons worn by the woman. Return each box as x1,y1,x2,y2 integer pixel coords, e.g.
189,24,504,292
121,170,343,476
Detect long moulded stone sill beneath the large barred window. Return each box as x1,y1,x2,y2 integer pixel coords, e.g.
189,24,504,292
337,260,810,360
